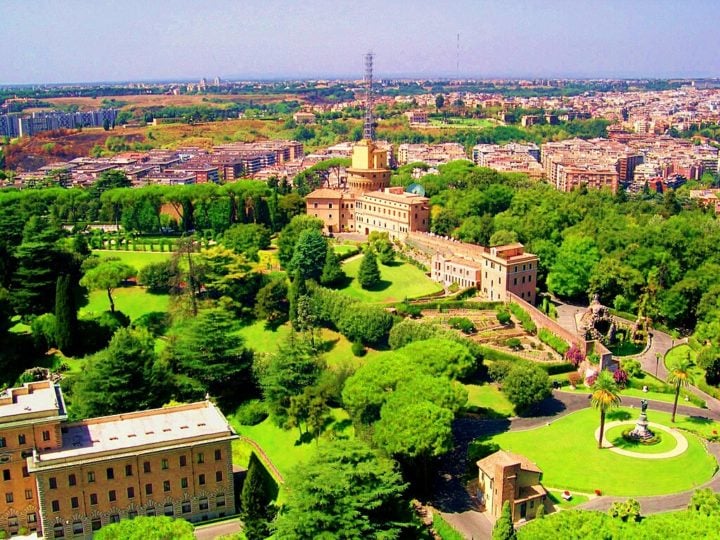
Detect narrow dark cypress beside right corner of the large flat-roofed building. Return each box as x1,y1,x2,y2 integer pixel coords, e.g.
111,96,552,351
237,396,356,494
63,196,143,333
240,452,278,540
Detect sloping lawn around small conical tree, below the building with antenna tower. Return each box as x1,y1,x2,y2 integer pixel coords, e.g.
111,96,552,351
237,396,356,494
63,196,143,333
341,257,442,303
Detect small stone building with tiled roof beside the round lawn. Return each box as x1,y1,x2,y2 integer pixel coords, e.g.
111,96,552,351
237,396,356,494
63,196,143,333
477,450,547,521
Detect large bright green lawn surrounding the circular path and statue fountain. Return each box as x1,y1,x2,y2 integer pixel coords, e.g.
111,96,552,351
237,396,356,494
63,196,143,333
486,408,717,496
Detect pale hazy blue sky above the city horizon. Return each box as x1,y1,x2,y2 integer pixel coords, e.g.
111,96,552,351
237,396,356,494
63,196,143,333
0,0,720,84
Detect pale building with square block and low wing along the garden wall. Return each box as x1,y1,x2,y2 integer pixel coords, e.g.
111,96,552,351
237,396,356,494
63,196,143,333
408,233,538,304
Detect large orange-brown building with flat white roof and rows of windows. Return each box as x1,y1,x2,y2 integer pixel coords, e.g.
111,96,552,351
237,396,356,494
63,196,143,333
0,381,237,538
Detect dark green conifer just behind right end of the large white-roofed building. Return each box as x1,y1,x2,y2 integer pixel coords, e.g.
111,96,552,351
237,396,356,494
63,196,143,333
165,308,254,406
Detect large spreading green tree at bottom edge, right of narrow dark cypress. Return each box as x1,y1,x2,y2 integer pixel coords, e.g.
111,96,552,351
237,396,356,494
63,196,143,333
274,440,407,540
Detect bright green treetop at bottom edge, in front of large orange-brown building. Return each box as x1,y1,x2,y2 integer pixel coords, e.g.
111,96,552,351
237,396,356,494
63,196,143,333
93,516,195,540
